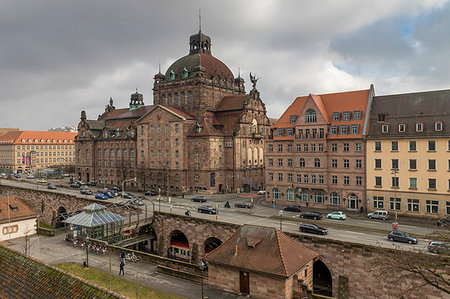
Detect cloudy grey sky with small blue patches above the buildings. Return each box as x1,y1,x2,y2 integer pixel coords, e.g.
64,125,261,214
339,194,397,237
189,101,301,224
0,0,450,130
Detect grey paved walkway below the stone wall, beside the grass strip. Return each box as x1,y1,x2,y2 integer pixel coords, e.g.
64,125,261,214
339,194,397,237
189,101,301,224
2,234,248,299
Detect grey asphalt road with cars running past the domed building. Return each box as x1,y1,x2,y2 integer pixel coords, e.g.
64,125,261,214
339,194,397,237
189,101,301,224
0,179,442,255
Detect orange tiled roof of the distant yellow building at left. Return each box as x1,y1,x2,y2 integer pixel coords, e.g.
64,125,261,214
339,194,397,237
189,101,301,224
0,131,78,144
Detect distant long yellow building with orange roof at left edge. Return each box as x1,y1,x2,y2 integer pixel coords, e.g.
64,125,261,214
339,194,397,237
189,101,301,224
0,131,77,173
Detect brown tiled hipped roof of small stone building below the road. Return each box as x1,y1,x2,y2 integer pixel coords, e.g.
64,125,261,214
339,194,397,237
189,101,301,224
204,224,319,277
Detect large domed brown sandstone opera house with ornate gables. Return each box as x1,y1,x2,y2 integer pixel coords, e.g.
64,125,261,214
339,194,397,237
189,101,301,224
76,31,271,192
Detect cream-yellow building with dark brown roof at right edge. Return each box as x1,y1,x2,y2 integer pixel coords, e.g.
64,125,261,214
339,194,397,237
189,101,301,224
366,90,450,217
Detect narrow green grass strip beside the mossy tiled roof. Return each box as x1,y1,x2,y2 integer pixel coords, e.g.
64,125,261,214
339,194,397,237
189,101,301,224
54,263,183,299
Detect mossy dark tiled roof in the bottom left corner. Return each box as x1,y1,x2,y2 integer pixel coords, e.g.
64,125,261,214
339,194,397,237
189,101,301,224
0,245,124,298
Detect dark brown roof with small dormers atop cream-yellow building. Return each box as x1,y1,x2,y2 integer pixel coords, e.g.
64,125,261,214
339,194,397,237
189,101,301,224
368,89,450,138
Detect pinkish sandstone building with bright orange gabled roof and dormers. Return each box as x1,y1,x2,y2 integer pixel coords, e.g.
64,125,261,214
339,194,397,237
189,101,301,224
266,86,374,210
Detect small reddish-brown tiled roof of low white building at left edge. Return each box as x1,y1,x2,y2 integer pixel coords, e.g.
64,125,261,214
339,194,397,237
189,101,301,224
0,197,37,224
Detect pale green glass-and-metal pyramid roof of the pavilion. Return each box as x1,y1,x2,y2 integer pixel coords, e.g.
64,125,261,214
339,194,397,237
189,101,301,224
64,203,125,227
